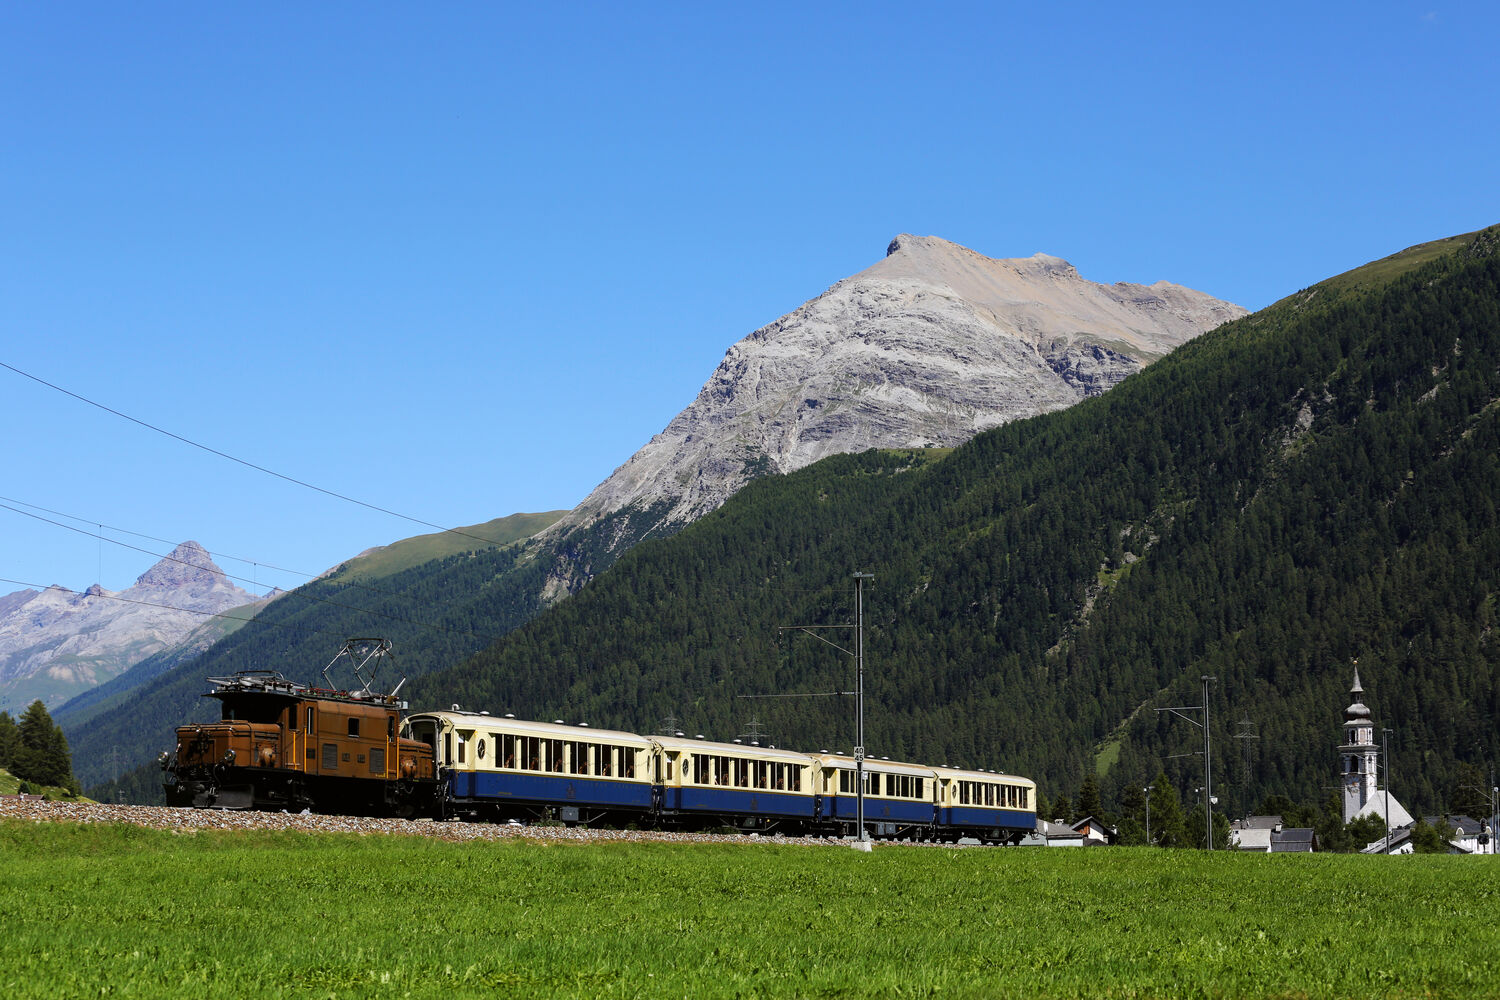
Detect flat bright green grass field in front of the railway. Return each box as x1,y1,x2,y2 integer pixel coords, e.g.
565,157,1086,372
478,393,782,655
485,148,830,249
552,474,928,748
0,822,1500,999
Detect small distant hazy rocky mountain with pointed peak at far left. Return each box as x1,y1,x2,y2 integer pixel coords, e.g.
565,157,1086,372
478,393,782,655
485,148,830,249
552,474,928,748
0,541,257,715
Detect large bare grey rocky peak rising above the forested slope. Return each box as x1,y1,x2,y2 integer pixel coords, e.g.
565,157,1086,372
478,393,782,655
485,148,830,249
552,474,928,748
539,234,1247,597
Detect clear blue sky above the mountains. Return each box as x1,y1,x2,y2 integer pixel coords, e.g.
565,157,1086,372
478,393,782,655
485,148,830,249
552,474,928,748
0,3,1500,594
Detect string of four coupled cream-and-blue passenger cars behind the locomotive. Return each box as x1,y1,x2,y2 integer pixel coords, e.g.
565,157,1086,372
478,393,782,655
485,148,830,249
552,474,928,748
404,711,1037,844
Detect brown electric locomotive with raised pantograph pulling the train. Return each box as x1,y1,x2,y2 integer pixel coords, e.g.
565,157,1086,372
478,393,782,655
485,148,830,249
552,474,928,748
162,640,438,816
